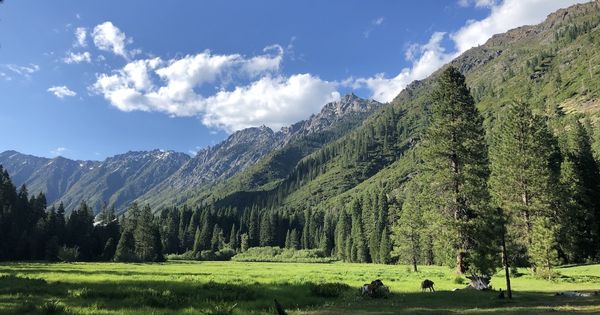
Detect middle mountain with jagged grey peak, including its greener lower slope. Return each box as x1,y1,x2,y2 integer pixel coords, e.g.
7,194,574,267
140,94,381,207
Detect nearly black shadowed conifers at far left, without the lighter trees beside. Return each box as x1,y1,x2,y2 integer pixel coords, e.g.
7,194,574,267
0,166,120,261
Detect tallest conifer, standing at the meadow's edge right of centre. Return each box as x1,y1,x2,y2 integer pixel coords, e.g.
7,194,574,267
421,66,493,274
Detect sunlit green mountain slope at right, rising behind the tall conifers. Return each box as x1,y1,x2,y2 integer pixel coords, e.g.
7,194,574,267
209,2,600,210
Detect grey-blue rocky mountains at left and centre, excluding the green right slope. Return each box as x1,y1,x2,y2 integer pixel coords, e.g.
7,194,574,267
0,94,381,211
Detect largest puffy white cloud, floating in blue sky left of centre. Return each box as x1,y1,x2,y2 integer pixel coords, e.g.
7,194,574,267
90,41,339,132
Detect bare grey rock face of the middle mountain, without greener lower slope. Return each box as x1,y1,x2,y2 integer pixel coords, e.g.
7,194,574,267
140,94,381,207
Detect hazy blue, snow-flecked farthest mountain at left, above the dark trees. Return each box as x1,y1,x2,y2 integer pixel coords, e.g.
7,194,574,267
0,150,189,211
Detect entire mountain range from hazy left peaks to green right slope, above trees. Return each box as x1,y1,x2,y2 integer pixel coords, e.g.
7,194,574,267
0,1,600,216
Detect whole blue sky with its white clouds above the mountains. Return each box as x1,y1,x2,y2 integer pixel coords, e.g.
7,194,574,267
0,0,585,160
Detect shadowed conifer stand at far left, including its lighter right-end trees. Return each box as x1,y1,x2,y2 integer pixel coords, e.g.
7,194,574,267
0,170,164,261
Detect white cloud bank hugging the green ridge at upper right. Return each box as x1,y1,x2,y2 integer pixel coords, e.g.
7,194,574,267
353,0,589,102
